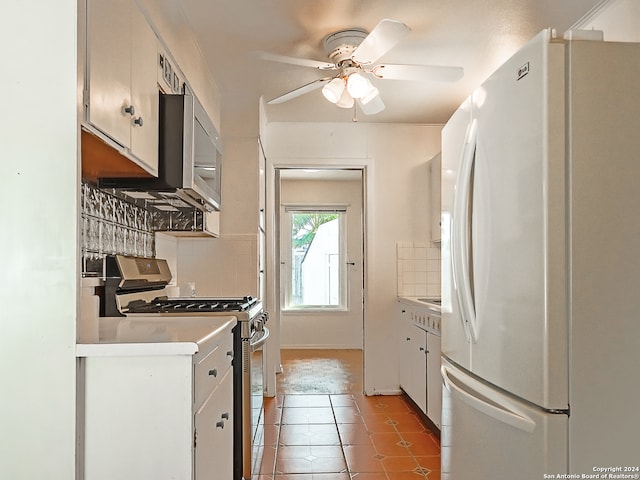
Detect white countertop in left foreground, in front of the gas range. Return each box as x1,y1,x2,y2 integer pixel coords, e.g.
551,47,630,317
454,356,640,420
76,316,236,357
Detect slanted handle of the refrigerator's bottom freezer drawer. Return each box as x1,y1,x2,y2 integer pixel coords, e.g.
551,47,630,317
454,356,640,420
441,365,536,433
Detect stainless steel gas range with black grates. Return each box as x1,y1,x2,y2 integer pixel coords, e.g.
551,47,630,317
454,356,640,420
100,255,269,480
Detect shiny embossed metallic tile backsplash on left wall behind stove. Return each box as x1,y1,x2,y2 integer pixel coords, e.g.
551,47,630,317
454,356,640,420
81,183,155,274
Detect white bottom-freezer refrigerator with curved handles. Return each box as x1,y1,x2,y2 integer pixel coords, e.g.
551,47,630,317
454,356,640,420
441,30,640,480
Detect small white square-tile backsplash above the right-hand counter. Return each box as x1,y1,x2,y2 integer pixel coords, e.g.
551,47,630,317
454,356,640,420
396,242,440,298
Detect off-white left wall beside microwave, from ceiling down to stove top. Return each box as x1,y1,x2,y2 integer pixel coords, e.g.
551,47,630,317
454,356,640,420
138,0,258,296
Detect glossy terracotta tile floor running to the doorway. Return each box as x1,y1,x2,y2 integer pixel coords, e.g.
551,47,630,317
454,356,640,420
254,350,440,480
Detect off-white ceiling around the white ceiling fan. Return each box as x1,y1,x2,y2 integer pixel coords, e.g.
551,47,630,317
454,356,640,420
175,0,606,128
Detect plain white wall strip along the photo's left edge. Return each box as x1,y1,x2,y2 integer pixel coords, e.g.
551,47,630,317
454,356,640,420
0,0,80,480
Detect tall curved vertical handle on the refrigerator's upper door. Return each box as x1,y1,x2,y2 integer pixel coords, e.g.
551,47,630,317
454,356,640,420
451,119,478,343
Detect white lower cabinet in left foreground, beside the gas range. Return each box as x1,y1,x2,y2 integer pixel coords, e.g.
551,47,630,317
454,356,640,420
78,321,235,480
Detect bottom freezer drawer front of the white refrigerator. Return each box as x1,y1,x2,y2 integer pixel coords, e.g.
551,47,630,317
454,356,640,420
441,360,568,480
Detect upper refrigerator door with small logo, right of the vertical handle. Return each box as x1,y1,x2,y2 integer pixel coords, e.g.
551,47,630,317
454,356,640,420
464,31,568,409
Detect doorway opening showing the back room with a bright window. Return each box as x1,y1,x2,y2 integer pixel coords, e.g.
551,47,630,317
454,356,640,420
274,167,365,390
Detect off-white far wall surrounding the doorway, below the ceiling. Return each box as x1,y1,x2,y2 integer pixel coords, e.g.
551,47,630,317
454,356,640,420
261,123,441,394
